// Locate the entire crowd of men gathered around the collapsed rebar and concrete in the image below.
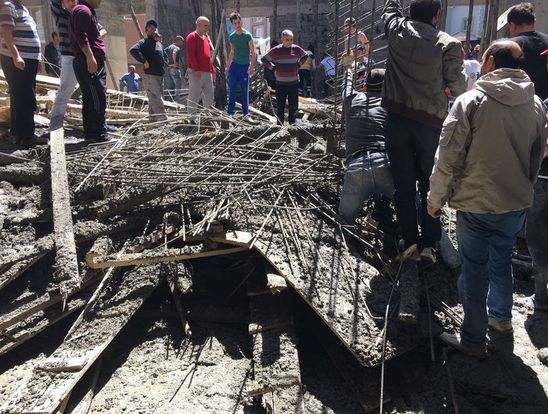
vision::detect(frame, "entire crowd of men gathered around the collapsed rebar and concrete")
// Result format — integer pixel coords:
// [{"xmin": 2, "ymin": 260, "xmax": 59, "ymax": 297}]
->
[{"xmin": 0, "ymin": 0, "xmax": 548, "ymax": 357}]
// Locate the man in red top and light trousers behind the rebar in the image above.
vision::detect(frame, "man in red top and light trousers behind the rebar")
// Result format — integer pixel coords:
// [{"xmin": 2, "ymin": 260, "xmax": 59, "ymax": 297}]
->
[{"xmin": 186, "ymin": 16, "xmax": 215, "ymax": 114}]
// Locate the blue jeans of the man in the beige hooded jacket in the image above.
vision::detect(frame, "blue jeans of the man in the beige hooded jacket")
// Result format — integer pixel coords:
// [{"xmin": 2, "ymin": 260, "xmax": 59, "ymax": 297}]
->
[{"xmin": 457, "ymin": 210, "xmax": 525, "ymax": 344}]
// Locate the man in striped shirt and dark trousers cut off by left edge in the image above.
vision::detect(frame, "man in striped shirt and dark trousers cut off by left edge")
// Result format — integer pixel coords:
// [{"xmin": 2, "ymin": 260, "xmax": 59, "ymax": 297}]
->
[{"xmin": 0, "ymin": 0, "xmax": 40, "ymax": 148}]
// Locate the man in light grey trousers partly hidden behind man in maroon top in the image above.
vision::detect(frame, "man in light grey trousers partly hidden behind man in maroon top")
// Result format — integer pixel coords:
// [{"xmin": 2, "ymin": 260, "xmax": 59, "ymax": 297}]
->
[{"xmin": 49, "ymin": 0, "xmax": 78, "ymax": 131}]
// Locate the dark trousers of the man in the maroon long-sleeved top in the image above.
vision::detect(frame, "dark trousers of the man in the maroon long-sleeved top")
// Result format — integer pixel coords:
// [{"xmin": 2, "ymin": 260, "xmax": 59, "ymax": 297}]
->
[{"xmin": 73, "ymin": 55, "xmax": 107, "ymax": 139}]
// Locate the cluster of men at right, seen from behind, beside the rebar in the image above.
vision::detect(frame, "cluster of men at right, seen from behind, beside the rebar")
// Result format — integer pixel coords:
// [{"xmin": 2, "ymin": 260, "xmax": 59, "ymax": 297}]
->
[{"xmin": 339, "ymin": 0, "xmax": 548, "ymax": 363}]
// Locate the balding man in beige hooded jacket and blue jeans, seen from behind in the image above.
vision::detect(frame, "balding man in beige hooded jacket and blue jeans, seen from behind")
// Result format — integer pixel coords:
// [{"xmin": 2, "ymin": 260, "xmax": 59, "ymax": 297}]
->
[{"xmin": 428, "ymin": 40, "xmax": 548, "ymax": 357}]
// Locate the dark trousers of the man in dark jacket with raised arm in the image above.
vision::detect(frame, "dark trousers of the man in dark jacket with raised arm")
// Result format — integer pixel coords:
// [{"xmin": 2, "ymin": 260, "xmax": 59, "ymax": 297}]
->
[{"xmin": 386, "ymin": 113, "xmax": 441, "ymax": 248}]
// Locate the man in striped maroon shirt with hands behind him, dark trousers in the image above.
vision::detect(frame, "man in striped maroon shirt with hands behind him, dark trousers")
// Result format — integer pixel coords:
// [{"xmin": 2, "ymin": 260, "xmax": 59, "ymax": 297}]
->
[{"xmin": 261, "ymin": 30, "xmax": 307, "ymax": 125}]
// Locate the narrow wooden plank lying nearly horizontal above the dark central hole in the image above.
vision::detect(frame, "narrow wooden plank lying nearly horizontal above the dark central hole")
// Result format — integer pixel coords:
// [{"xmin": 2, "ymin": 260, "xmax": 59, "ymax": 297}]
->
[{"xmin": 86, "ymin": 247, "xmax": 248, "ymax": 269}]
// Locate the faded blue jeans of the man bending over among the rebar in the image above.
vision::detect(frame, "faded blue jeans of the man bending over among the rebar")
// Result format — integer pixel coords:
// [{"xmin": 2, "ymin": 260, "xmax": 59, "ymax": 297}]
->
[{"xmin": 339, "ymin": 152, "xmax": 394, "ymax": 224}]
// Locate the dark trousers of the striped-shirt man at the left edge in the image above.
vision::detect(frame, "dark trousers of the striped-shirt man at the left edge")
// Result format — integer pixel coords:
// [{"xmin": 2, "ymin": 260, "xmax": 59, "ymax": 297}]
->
[{"xmin": 0, "ymin": 56, "xmax": 38, "ymax": 143}]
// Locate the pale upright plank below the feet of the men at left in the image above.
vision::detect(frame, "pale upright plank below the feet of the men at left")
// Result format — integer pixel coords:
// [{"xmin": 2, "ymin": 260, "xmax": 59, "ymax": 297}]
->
[{"xmin": 50, "ymin": 128, "xmax": 81, "ymax": 298}]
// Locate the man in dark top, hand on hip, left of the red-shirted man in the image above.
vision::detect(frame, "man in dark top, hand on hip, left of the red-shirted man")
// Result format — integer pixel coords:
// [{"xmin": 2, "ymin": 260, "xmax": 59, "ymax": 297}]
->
[{"xmin": 129, "ymin": 20, "xmax": 167, "ymax": 121}]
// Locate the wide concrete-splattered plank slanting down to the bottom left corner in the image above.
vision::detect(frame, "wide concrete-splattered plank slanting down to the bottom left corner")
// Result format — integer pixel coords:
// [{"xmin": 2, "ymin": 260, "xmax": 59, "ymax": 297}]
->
[{"xmin": 0, "ymin": 265, "xmax": 165, "ymax": 414}]
